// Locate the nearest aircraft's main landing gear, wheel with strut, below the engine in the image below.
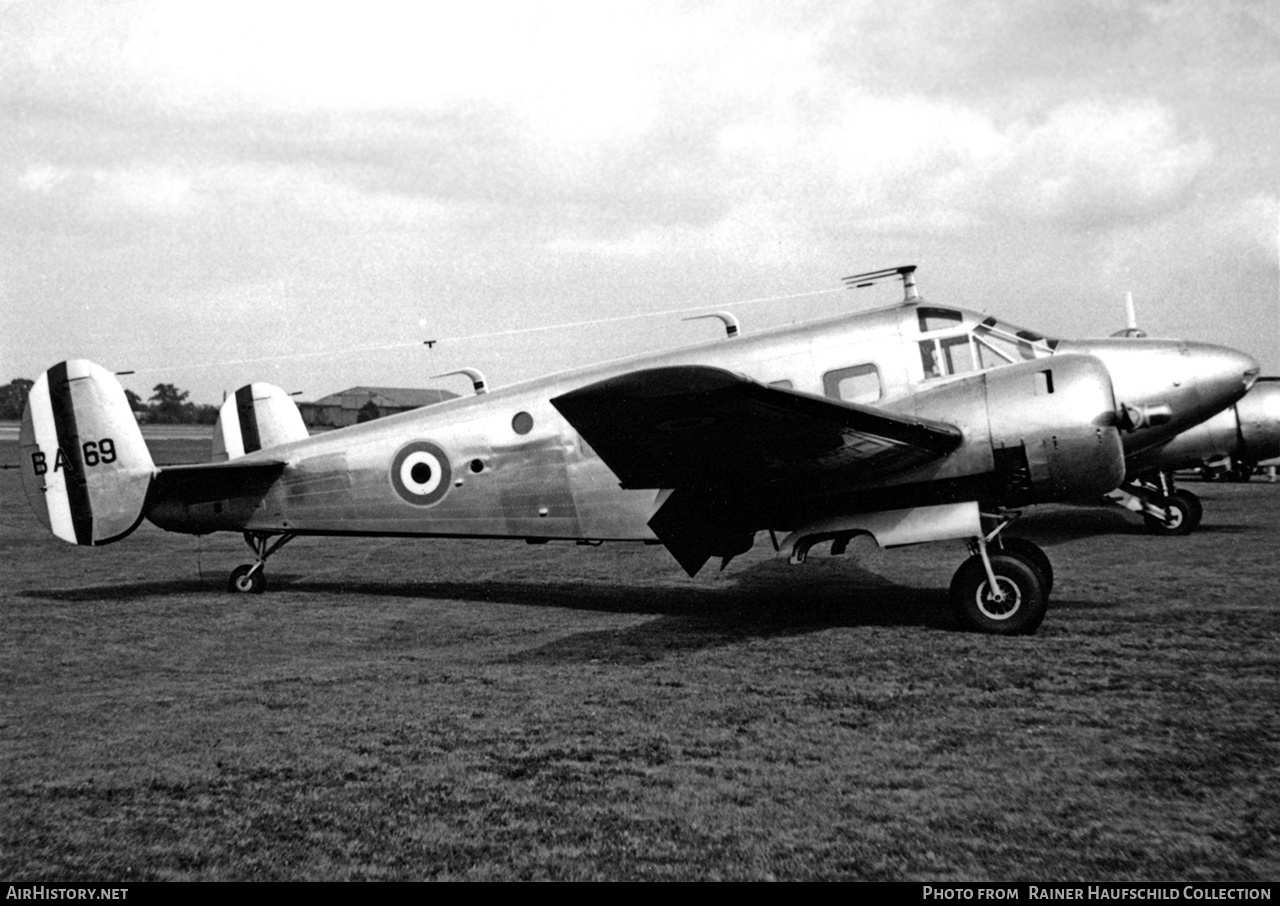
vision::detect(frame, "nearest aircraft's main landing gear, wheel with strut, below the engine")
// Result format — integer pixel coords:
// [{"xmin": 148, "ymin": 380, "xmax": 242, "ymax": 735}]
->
[{"xmin": 950, "ymin": 522, "xmax": 1053, "ymax": 636}]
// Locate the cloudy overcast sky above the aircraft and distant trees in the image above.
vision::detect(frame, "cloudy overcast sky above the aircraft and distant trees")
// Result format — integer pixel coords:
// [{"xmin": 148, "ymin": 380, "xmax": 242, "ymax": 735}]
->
[{"xmin": 0, "ymin": 0, "xmax": 1280, "ymax": 402}]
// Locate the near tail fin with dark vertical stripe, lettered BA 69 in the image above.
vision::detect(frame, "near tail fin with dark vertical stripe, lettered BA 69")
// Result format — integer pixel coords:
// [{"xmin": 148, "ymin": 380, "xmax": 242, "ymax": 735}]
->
[{"xmin": 19, "ymin": 358, "xmax": 155, "ymax": 545}]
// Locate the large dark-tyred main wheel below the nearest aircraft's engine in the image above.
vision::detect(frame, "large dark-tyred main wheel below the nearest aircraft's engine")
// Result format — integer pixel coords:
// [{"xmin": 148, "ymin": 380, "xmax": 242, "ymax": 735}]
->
[{"xmin": 951, "ymin": 552, "xmax": 1048, "ymax": 636}]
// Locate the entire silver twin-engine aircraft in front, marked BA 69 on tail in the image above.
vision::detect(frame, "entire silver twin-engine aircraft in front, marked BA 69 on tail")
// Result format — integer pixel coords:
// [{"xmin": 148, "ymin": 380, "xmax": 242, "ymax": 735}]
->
[{"xmin": 22, "ymin": 266, "xmax": 1258, "ymax": 635}]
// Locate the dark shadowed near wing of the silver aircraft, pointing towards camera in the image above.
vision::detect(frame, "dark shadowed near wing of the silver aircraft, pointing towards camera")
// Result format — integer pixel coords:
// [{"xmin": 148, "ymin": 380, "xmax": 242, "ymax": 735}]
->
[{"xmin": 550, "ymin": 366, "xmax": 961, "ymax": 493}]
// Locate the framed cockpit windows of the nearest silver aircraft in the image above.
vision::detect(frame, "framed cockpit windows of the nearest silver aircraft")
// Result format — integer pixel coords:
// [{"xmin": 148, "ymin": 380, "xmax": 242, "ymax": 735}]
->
[{"xmin": 919, "ymin": 307, "xmax": 1057, "ymax": 380}]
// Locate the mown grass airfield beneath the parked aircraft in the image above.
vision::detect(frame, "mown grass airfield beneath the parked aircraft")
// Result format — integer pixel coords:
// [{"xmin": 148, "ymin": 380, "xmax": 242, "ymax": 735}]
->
[{"xmin": 0, "ymin": 437, "xmax": 1280, "ymax": 880}]
